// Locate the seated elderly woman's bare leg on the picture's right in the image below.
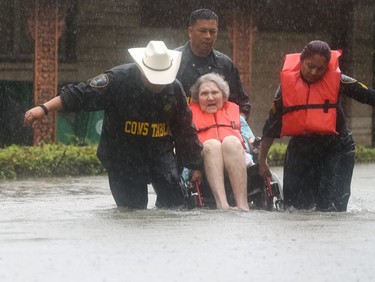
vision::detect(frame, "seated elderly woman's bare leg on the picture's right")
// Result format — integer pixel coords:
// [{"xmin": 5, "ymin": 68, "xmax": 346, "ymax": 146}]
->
[{"xmin": 222, "ymin": 136, "xmax": 249, "ymax": 211}]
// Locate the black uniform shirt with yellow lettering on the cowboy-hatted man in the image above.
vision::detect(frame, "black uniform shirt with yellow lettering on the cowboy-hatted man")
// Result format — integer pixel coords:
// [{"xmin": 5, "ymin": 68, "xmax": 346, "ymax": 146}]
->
[{"xmin": 59, "ymin": 64, "xmax": 202, "ymax": 173}]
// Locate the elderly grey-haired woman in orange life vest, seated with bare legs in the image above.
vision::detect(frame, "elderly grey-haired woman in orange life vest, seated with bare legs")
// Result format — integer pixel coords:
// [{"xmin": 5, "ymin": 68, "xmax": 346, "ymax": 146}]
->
[{"xmin": 190, "ymin": 73, "xmax": 249, "ymax": 211}]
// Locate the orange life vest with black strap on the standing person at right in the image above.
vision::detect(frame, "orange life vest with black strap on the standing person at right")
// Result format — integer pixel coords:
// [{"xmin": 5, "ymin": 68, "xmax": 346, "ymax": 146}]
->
[{"xmin": 280, "ymin": 50, "xmax": 341, "ymax": 136}]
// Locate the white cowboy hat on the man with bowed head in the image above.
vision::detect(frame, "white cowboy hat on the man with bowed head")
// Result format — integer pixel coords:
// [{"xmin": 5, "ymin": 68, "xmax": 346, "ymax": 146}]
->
[{"xmin": 128, "ymin": 41, "xmax": 181, "ymax": 85}]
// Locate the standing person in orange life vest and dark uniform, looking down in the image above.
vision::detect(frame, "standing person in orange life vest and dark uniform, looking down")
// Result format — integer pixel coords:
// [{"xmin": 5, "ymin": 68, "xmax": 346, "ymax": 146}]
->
[{"xmin": 259, "ymin": 40, "xmax": 375, "ymax": 211}]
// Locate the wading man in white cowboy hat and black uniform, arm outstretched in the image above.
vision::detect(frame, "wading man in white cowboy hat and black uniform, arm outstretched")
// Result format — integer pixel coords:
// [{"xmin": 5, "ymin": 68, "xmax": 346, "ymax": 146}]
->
[{"xmin": 24, "ymin": 41, "xmax": 203, "ymax": 209}]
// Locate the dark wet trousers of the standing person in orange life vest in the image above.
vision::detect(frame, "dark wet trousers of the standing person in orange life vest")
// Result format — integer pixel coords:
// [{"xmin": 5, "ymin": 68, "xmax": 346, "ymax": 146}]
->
[{"xmin": 283, "ymin": 132, "xmax": 355, "ymax": 211}]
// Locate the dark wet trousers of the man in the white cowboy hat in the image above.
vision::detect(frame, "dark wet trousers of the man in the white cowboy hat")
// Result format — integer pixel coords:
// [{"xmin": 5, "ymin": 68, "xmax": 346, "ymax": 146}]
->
[{"xmin": 107, "ymin": 152, "xmax": 184, "ymax": 209}]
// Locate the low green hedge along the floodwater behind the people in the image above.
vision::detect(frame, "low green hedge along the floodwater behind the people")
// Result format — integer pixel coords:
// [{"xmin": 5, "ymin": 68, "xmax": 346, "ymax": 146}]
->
[{"xmin": 0, "ymin": 143, "xmax": 375, "ymax": 179}]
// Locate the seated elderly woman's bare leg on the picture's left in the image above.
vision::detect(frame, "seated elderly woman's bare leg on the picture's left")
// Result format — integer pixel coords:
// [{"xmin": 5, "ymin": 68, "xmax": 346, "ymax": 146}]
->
[{"xmin": 202, "ymin": 139, "xmax": 230, "ymax": 209}]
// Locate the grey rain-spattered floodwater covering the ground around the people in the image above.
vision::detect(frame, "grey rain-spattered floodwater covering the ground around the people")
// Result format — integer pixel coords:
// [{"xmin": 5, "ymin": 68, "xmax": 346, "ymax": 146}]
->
[{"xmin": 0, "ymin": 164, "xmax": 375, "ymax": 282}]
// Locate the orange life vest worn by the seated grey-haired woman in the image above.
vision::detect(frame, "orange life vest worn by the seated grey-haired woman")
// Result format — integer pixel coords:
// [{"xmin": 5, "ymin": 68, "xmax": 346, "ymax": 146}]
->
[{"xmin": 189, "ymin": 102, "xmax": 243, "ymax": 145}]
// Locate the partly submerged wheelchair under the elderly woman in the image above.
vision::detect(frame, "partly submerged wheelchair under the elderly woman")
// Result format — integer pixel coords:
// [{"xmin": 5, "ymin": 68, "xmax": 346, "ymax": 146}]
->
[{"xmin": 180, "ymin": 138, "xmax": 285, "ymax": 211}]
